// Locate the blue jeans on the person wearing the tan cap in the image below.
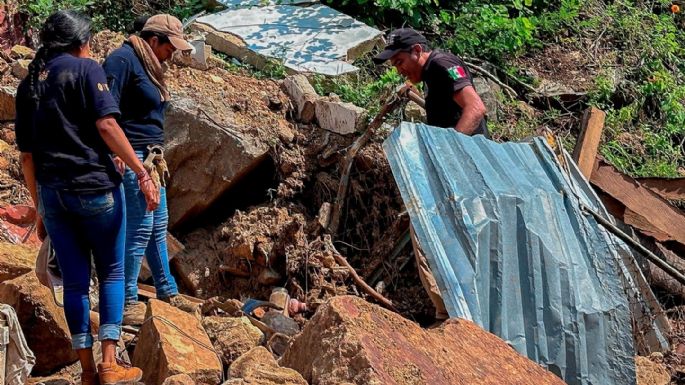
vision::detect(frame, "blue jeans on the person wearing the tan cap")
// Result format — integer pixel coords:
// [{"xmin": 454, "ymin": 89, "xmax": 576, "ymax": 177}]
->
[{"xmin": 124, "ymin": 151, "xmax": 178, "ymax": 304}]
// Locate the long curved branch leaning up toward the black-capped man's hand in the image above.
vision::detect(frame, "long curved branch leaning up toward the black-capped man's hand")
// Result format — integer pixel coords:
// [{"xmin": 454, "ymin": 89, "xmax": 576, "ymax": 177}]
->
[{"xmin": 328, "ymin": 95, "xmax": 402, "ymax": 235}]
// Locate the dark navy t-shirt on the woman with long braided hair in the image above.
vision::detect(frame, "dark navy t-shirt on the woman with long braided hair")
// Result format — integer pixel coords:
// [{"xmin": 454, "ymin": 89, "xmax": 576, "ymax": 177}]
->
[{"xmin": 15, "ymin": 53, "xmax": 121, "ymax": 192}]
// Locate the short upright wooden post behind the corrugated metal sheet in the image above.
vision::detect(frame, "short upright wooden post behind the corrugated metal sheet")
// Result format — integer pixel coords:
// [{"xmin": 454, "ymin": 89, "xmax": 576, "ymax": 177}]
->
[{"xmin": 573, "ymin": 107, "xmax": 606, "ymax": 180}]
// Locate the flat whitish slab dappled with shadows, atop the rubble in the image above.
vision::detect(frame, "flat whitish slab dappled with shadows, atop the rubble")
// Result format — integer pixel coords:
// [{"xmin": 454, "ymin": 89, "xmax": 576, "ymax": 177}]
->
[{"xmin": 197, "ymin": 4, "xmax": 381, "ymax": 75}]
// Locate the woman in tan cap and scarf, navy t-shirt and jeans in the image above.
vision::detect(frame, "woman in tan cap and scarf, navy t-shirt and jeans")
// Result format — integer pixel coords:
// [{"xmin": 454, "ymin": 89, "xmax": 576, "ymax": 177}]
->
[{"xmin": 104, "ymin": 15, "xmax": 197, "ymax": 325}]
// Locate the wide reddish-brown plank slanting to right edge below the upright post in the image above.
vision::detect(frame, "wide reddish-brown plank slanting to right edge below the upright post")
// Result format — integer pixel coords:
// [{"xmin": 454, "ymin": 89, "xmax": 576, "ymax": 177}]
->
[{"xmin": 590, "ymin": 160, "xmax": 685, "ymax": 245}]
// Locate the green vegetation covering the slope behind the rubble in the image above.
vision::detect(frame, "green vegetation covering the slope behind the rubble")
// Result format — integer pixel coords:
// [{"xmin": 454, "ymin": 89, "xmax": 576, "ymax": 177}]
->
[{"xmin": 19, "ymin": 0, "xmax": 685, "ymax": 176}]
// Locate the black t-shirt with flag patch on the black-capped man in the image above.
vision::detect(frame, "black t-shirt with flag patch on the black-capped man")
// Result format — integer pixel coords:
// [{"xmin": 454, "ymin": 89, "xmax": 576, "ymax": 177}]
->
[{"xmin": 421, "ymin": 51, "xmax": 488, "ymax": 137}]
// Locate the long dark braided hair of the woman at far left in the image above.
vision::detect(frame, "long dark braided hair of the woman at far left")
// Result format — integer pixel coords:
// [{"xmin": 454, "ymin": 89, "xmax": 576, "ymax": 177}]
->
[{"xmin": 28, "ymin": 10, "xmax": 92, "ymax": 105}]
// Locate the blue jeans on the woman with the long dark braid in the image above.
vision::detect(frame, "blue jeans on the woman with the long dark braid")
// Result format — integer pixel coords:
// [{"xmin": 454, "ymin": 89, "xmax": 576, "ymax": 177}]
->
[{"xmin": 37, "ymin": 185, "xmax": 126, "ymax": 349}]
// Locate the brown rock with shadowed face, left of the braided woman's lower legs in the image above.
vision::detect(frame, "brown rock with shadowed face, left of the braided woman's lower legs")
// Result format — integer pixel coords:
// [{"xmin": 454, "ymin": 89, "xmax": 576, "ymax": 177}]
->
[{"xmin": 0, "ymin": 272, "xmax": 78, "ymax": 375}]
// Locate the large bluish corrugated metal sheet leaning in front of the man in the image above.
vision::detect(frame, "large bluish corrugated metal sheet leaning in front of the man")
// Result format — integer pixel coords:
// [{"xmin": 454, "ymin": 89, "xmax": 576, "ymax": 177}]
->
[{"xmin": 384, "ymin": 123, "xmax": 651, "ymax": 385}]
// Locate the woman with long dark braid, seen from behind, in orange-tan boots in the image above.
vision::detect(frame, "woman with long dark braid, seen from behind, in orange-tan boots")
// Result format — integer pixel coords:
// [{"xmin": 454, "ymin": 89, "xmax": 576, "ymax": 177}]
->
[{"xmin": 15, "ymin": 11, "xmax": 159, "ymax": 385}]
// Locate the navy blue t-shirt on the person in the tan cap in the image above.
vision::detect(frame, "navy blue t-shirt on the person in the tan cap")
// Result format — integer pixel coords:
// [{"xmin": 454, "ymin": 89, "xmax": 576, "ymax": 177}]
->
[{"xmin": 103, "ymin": 42, "xmax": 168, "ymax": 151}]
